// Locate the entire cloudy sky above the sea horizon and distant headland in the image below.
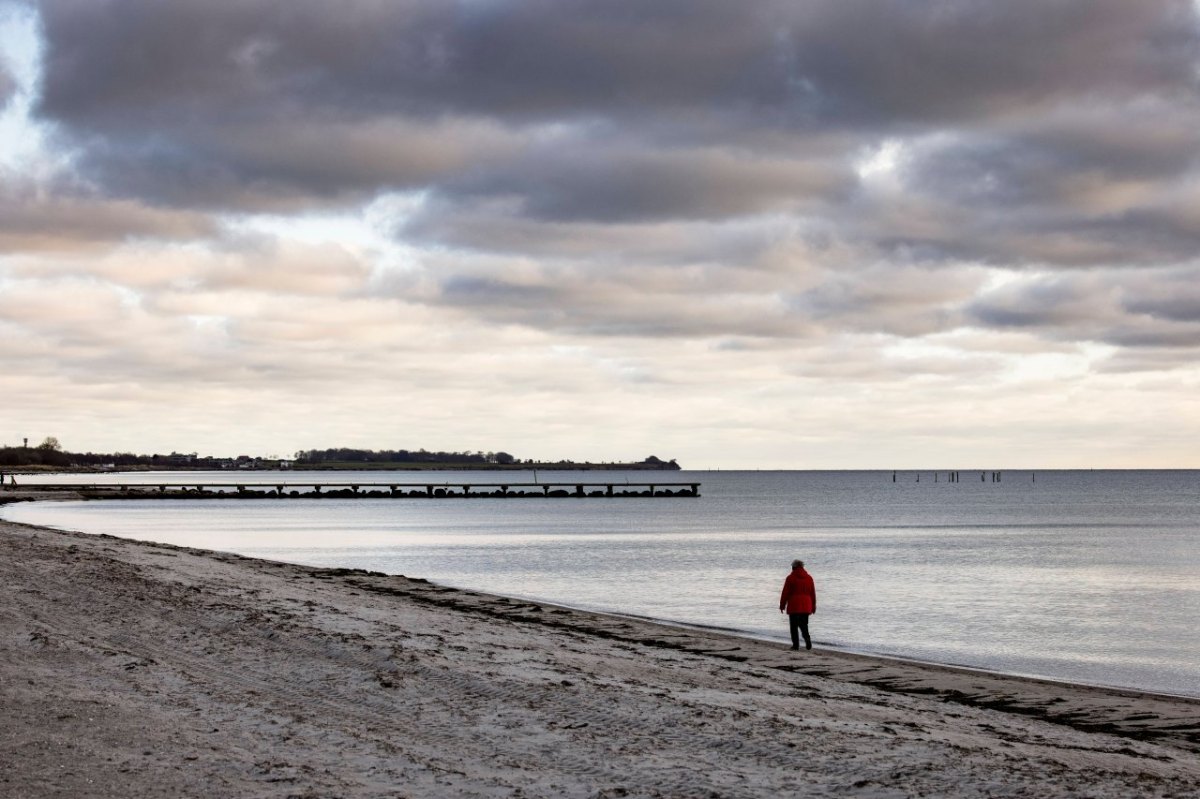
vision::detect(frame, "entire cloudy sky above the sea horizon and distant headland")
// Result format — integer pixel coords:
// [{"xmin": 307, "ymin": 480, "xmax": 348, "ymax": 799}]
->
[{"xmin": 0, "ymin": 0, "xmax": 1200, "ymax": 469}]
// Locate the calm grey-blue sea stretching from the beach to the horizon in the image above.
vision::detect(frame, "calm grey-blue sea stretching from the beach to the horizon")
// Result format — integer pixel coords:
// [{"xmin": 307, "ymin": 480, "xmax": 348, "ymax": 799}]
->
[{"xmin": 0, "ymin": 471, "xmax": 1200, "ymax": 696}]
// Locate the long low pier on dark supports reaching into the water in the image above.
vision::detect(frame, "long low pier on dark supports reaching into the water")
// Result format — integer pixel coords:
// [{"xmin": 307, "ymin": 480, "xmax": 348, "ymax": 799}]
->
[{"xmin": 22, "ymin": 480, "xmax": 700, "ymax": 499}]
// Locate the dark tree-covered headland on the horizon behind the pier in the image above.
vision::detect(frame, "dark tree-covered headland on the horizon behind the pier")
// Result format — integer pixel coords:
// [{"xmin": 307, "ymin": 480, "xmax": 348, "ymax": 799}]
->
[{"xmin": 0, "ymin": 437, "xmax": 682, "ymax": 473}]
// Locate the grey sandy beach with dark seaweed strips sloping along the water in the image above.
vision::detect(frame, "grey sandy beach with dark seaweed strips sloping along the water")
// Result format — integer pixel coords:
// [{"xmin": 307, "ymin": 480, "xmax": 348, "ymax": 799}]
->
[{"xmin": 0, "ymin": 513, "xmax": 1200, "ymax": 798}]
